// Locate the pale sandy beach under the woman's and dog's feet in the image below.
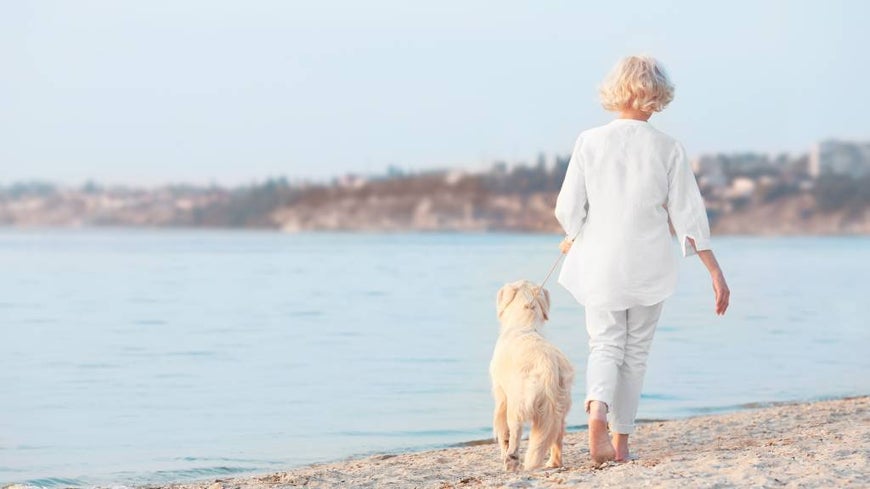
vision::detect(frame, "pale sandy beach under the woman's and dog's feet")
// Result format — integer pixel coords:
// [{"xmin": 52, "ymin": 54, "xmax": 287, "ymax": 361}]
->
[{"xmin": 112, "ymin": 397, "xmax": 870, "ymax": 489}]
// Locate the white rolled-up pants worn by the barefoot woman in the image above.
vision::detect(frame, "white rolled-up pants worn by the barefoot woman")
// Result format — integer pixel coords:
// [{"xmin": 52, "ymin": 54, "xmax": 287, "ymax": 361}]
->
[{"xmin": 586, "ymin": 302, "xmax": 664, "ymax": 434}]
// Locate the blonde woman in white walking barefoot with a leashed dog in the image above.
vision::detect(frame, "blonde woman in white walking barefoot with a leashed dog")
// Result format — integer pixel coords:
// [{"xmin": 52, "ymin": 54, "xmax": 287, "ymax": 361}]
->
[{"xmin": 555, "ymin": 56, "xmax": 730, "ymax": 463}]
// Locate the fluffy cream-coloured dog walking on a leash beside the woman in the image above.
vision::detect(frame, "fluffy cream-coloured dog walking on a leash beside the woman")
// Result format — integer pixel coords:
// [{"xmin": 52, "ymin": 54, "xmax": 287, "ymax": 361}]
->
[{"xmin": 489, "ymin": 280, "xmax": 574, "ymax": 470}]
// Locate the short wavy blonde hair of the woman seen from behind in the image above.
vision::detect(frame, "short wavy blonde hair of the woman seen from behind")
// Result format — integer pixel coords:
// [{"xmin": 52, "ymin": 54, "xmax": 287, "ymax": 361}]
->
[{"xmin": 598, "ymin": 56, "xmax": 674, "ymax": 112}]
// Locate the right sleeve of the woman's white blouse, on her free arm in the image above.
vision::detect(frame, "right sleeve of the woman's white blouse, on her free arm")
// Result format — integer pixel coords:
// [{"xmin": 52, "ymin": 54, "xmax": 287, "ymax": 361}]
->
[{"xmin": 667, "ymin": 142, "xmax": 711, "ymax": 257}]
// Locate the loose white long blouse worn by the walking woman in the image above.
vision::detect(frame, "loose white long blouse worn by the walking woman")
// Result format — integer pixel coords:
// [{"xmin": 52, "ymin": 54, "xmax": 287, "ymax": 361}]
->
[{"xmin": 555, "ymin": 119, "xmax": 710, "ymax": 310}]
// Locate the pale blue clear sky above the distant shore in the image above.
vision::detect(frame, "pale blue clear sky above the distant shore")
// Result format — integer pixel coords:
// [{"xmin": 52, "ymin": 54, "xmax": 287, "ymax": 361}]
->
[{"xmin": 0, "ymin": 0, "xmax": 870, "ymax": 185}]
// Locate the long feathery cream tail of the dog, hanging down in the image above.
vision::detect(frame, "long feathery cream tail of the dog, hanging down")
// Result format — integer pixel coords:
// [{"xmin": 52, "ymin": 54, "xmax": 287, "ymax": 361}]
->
[{"xmin": 523, "ymin": 355, "xmax": 574, "ymax": 470}]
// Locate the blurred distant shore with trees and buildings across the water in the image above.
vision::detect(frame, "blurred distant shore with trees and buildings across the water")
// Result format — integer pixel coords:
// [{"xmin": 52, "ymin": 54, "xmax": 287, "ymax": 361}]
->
[{"xmin": 0, "ymin": 172, "xmax": 870, "ymax": 236}]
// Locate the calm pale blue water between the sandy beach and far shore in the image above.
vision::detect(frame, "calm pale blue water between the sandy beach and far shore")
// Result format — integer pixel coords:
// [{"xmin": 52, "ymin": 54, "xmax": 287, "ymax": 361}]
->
[{"xmin": 0, "ymin": 230, "xmax": 870, "ymax": 487}]
